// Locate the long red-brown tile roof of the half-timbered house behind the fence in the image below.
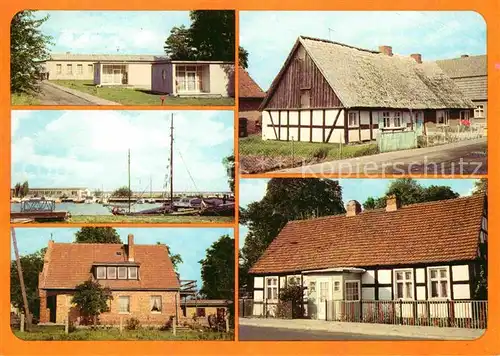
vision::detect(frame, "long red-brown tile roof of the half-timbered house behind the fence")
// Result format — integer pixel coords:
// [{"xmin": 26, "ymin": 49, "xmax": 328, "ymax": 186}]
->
[{"xmin": 250, "ymin": 195, "xmax": 486, "ymax": 274}]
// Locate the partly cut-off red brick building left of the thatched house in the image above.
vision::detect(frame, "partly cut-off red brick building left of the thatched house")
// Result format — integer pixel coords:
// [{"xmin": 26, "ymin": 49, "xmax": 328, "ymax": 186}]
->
[{"xmin": 238, "ymin": 67, "xmax": 266, "ymax": 137}]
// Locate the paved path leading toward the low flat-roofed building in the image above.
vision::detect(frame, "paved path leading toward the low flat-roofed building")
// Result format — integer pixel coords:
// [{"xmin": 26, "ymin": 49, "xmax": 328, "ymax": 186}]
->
[{"xmin": 39, "ymin": 81, "xmax": 121, "ymax": 105}]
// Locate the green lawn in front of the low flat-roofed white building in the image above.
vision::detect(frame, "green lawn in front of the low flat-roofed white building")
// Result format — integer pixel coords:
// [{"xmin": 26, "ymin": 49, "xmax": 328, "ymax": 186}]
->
[{"xmin": 51, "ymin": 80, "xmax": 234, "ymax": 106}]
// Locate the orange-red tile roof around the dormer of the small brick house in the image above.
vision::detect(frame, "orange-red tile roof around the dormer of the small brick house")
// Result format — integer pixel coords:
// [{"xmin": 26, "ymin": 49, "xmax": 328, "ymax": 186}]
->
[{"xmin": 39, "ymin": 243, "xmax": 179, "ymax": 290}]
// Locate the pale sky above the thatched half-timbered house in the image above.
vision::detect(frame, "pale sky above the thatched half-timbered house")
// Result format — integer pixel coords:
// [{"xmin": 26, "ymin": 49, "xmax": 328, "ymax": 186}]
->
[{"xmin": 240, "ymin": 11, "xmax": 486, "ymax": 90}]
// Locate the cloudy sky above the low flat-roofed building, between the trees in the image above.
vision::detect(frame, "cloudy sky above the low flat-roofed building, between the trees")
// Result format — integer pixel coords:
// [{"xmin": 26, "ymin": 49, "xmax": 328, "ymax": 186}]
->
[{"xmin": 37, "ymin": 11, "xmax": 191, "ymax": 54}]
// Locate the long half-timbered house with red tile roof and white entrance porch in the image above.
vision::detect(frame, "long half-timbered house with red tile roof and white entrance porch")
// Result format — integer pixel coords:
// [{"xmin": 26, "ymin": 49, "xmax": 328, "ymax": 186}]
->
[{"xmin": 252, "ymin": 195, "xmax": 487, "ymax": 320}]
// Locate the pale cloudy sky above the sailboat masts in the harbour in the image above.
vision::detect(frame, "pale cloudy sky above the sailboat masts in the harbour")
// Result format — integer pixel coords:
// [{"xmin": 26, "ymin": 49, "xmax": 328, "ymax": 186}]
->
[{"xmin": 11, "ymin": 110, "xmax": 234, "ymax": 192}]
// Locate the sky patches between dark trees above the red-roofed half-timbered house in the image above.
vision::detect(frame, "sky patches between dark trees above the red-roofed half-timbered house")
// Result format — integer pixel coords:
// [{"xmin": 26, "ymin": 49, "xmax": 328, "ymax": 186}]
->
[{"xmin": 239, "ymin": 179, "xmax": 476, "ymax": 248}]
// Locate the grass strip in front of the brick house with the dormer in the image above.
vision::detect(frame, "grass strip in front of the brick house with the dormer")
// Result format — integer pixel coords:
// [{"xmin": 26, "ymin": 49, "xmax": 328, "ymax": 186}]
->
[{"xmin": 14, "ymin": 326, "xmax": 234, "ymax": 341}]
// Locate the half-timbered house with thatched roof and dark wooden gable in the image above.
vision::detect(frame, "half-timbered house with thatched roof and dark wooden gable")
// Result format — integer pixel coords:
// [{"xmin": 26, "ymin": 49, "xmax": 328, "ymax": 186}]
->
[{"xmin": 260, "ymin": 36, "xmax": 475, "ymax": 143}]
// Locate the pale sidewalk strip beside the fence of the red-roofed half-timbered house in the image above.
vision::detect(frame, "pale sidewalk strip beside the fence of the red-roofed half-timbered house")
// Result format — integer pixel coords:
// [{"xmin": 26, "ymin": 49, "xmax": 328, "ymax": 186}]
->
[{"xmin": 239, "ymin": 318, "xmax": 485, "ymax": 340}]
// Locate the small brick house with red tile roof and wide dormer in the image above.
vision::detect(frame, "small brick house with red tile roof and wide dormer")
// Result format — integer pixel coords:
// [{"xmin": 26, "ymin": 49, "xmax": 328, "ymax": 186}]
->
[{"xmin": 38, "ymin": 235, "xmax": 180, "ymax": 325}]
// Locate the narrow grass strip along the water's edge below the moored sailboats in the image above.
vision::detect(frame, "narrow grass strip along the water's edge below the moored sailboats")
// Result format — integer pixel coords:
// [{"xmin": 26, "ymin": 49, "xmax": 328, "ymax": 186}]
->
[{"xmin": 68, "ymin": 215, "xmax": 234, "ymax": 224}]
